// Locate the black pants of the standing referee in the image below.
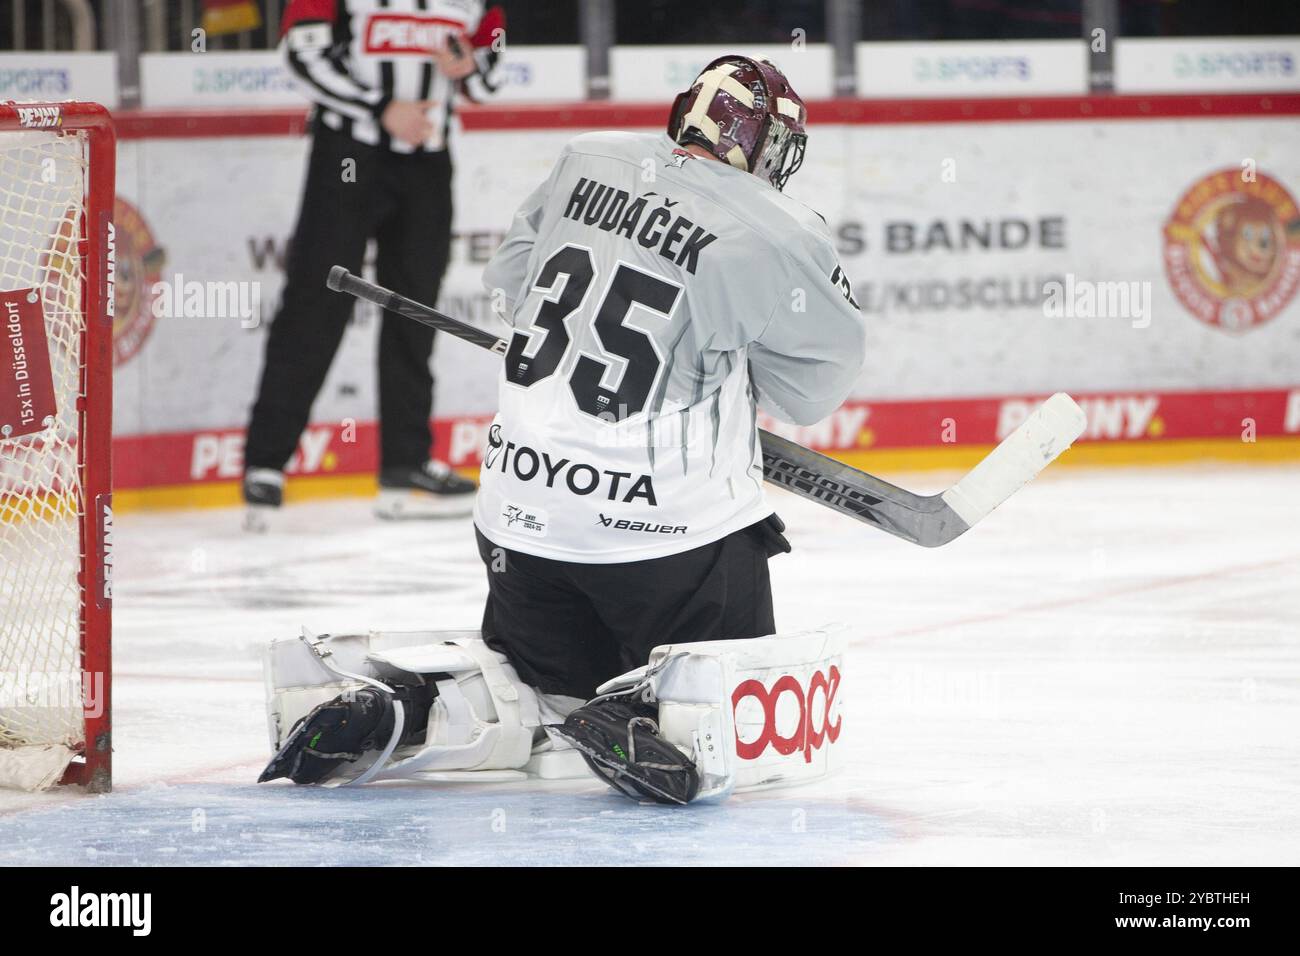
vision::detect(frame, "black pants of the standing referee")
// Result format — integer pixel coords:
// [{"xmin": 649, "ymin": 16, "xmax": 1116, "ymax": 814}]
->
[{"xmin": 244, "ymin": 122, "xmax": 451, "ymax": 470}]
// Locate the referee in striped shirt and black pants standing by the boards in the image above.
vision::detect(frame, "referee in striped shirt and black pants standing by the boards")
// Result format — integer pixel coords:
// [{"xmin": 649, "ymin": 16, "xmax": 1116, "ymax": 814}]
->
[{"xmin": 243, "ymin": 0, "xmax": 504, "ymax": 531}]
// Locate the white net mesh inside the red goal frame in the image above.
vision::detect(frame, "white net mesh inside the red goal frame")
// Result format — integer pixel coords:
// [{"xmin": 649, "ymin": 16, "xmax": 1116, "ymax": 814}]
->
[{"xmin": 0, "ymin": 130, "xmax": 87, "ymax": 748}]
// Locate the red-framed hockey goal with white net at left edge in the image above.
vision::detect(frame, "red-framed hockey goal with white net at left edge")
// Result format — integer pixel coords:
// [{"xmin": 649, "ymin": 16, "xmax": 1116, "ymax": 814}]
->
[{"xmin": 0, "ymin": 103, "xmax": 114, "ymax": 791}]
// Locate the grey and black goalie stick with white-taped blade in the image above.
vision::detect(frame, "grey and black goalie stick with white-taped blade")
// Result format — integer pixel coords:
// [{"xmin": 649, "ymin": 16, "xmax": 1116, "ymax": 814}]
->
[{"xmin": 326, "ymin": 265, "xmax": 1086, "ymax": 548}]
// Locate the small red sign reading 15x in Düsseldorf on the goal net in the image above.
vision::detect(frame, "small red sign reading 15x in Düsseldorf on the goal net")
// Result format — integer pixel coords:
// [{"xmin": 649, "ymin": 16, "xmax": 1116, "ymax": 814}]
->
[{"xmin": 0, "ymin": 289, "xmax": 59, "ymax": 441}]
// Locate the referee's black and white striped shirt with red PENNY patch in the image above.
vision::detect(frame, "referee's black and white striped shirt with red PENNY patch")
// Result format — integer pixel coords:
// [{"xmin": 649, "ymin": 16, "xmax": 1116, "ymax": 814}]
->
[{"xmin": 280, "ymin": 0, "xmax": 506, "ymax": 152}]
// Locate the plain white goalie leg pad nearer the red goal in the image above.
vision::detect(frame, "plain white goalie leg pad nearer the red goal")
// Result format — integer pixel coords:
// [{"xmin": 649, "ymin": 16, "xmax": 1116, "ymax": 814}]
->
[{"xmin": 265, "ymin": 631, "xmax": 553, "ymax": 783}]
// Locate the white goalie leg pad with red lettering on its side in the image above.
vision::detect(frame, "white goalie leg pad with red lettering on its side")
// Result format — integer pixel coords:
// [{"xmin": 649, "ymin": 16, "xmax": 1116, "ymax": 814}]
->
[{"xmin": 599, "ymin": 631, "xmax": 845, "ymax": 799}]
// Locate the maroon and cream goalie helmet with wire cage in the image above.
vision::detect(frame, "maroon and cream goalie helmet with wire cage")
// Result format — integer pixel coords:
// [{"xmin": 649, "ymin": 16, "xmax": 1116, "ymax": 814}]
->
[{"xmin": 668, "ymin": 56, "xmax": 807, "ymax": 189}]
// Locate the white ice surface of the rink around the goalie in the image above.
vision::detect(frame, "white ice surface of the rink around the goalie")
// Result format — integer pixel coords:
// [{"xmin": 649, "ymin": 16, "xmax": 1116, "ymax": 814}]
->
[{"xmin": 0, "ymin": 466, "xmax": 1300, "ymax": 865}]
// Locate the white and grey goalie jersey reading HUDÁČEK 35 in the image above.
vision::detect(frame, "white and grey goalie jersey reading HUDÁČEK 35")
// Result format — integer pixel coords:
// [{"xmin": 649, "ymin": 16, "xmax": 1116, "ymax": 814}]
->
[{"xmin": 475, "ymin": 133, "xmax": 865, "ymax": 563}]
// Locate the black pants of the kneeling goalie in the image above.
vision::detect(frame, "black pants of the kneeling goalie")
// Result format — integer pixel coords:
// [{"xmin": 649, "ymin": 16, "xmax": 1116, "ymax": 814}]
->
[{"xmin": 475, "ymin": 515, "xmax": 790, "ymax": 700}]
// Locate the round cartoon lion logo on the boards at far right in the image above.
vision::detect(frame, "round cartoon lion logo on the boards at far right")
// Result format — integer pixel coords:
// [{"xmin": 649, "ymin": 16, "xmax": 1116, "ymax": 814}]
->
[{"xmin": 1165, "ymin": 168, "xmax": 1300, "ymax": 332}]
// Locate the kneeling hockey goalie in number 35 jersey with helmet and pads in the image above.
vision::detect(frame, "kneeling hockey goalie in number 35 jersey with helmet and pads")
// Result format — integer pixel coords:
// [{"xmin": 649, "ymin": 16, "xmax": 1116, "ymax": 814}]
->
[{"xmin": 261, "ymin": 56, "xmax": 865, "ymax": 804}]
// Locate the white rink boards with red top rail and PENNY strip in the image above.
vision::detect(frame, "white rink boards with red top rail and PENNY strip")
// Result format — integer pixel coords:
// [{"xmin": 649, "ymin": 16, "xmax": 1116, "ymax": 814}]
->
[{"xmin": 91, "ymin": 95, "xmax": 1300, "ymax": 505}]
